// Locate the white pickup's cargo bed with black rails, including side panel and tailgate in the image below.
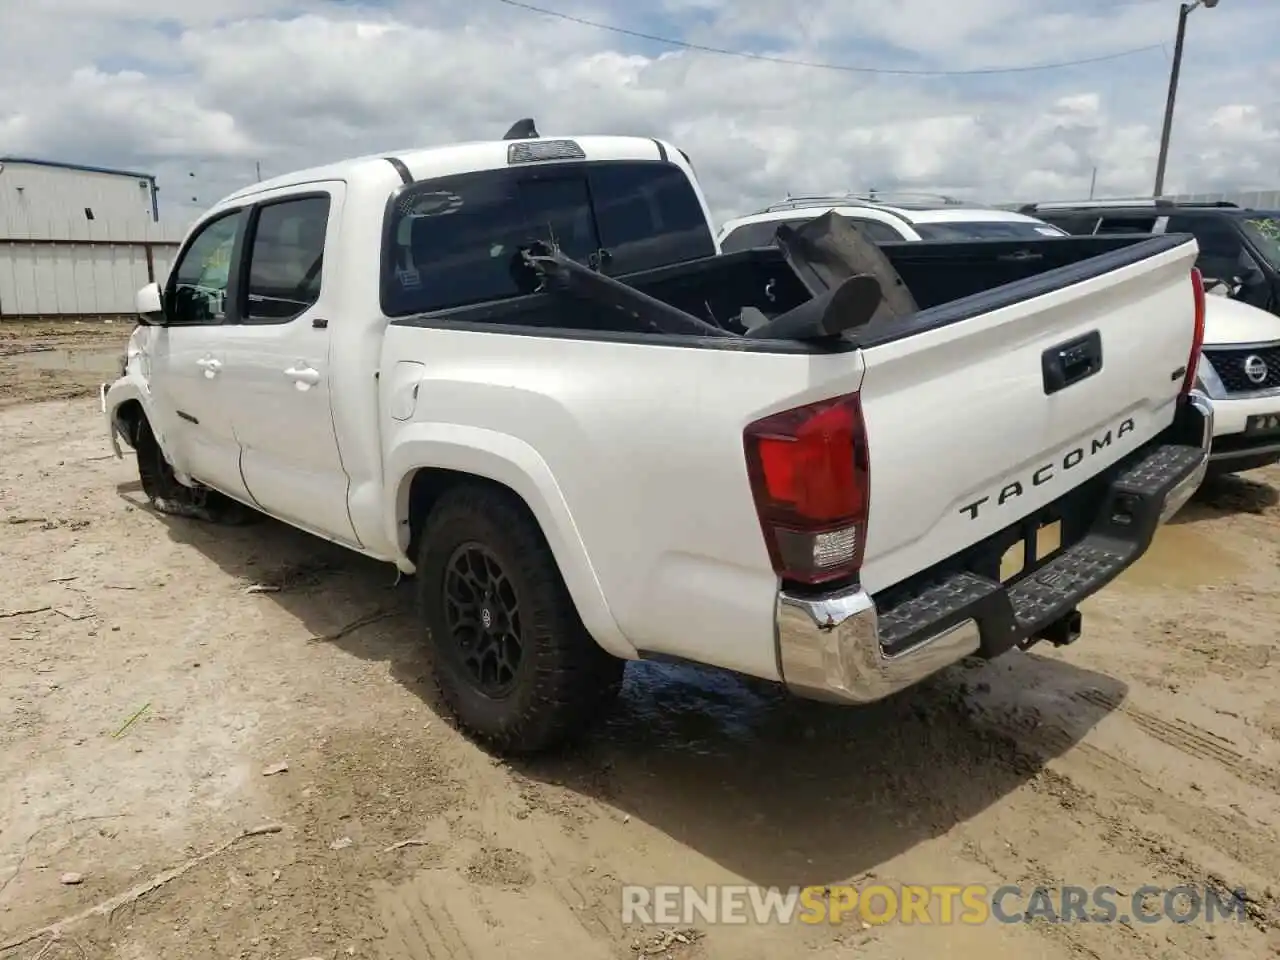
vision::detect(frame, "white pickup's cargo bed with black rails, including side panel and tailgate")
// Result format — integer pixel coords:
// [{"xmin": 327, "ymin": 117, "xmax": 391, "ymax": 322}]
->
[{"xmin": 379, "ymin": 222, "xmax": 1198, "ymax": 677}]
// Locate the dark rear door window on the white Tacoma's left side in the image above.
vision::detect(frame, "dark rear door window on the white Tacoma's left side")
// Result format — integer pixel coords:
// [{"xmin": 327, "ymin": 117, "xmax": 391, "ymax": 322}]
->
[{"xmin": 244, "ymin": 196, "xmax": 329, "ymax": 324}]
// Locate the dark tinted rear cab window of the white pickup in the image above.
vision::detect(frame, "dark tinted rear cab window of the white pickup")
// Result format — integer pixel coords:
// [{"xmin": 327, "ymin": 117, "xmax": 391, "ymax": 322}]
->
[{"xmin": 381, "ymin": 160, "xmax": 716, "ymax": 316}]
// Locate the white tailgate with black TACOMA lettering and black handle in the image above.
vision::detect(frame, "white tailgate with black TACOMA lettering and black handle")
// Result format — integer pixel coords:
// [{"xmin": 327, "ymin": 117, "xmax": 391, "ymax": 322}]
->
[{"xmin": 860, "ymin": 238, "xmax": 1197, "ymax": 594}]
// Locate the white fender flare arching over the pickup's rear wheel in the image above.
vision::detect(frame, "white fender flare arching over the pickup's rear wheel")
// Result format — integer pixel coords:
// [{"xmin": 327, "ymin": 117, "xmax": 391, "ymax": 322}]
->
[{"xmin": 385, "ymin": 424, "xmax": 639, "ymax": 659}]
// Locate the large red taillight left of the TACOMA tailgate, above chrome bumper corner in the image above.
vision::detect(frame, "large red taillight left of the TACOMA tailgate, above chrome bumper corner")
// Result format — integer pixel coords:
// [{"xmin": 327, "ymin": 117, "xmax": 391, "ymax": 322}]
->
[{"xmin": 742, "ymin": 393, "xmax": 870, "ymax": 584}]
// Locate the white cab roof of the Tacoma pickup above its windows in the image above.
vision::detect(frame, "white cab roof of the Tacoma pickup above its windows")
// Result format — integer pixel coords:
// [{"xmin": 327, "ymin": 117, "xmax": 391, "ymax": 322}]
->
[{"xmin": 219, "ymin": 136, "xmax": 680, "ymax": 205}]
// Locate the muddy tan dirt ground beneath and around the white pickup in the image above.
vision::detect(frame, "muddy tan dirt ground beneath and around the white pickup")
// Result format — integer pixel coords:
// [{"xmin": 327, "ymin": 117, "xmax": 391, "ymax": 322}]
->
[{"xmin": 0, "ymin": 328, "xmax": 1280, "ymax": 960}]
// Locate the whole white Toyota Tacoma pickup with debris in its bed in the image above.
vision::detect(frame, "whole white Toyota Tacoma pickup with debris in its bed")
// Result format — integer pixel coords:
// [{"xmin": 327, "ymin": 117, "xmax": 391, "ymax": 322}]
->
[{"xmin": 102, "ymin": 128, "xmax": 1212, "ymax": 751}]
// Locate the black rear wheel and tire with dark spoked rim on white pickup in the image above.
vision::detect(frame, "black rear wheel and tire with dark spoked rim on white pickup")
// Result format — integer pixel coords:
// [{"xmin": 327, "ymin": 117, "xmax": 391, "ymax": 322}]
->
[{"xmin": 416, "ymin": 484, "xmax": 625, "ymax": 754}]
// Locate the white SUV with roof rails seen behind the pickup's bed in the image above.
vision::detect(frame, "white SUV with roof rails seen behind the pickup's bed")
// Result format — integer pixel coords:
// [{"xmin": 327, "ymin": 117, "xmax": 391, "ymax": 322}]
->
[{"xmin": 718, "ymin": 193, "xmax": 1070, "ymax": 253}]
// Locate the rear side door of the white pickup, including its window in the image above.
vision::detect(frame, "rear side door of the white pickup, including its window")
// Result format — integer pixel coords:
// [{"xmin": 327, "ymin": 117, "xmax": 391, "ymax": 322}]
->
[{"xmin": 218, "ymin": 182, "xmax": 361, "ymax": 547}]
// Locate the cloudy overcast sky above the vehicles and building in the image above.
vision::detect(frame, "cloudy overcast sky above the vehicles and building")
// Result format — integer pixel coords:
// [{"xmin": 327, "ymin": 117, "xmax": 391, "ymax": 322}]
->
[{"xmin": 0, "ymin": 0, "xmax": 1280, "ymax": 227}]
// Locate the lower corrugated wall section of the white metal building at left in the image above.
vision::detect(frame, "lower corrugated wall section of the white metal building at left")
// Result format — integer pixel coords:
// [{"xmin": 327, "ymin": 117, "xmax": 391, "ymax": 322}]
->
[{"xmin": 0, "ymin": 209, "xmax": 182, "ymax": 321}]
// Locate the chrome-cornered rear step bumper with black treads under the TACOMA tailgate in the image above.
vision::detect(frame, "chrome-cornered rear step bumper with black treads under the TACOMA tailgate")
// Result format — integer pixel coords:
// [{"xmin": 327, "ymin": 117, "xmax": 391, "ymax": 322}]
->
[{"xmin": 776, "ymin": 393, "xmax": 1213, "ymax": 703}]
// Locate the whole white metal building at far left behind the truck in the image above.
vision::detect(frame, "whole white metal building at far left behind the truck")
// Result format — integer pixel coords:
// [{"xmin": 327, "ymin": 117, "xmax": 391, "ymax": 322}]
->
[{"xmin": 0, "ymin": 156, "xmax": 180, "ymax": 321}]
